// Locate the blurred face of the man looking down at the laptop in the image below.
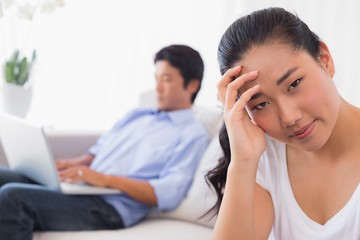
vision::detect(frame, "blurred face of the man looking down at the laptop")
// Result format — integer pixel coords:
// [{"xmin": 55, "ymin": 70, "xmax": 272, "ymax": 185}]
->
[{"xmin": 155, "ymin": 60, "xmax": 193, "ymax": 111}]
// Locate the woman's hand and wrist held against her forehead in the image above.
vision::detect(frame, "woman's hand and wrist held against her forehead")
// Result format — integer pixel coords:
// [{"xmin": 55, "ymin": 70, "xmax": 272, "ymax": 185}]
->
[{"xmin": 217, "ymin": 66, "xmax": 266, "ymax": 161}]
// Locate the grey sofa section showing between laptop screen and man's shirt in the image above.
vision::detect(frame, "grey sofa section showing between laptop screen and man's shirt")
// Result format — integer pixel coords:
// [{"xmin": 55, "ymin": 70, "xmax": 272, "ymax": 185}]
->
[{"xmin": 45, "ymin": 130, "xmax": 101, "ymax": 159}]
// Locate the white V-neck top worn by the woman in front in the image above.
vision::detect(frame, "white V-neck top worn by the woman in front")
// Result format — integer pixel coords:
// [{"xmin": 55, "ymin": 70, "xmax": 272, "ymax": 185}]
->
[{"xmin": 256, "ymin": 137, "xmax": 360, "ymax": 240}]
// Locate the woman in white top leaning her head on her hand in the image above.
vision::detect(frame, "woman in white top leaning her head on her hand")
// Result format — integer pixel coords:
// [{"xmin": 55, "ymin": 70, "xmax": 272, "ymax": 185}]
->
[{"xmin": 207, "ymin": 8, "xmax": 360, "ymax": 240}]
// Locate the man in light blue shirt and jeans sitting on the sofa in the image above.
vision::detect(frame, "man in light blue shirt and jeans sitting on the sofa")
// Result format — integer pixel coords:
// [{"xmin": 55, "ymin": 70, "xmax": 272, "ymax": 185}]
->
[{"xmin": 0, "ymin": 45, "xmax": 209, "ymax": 240}]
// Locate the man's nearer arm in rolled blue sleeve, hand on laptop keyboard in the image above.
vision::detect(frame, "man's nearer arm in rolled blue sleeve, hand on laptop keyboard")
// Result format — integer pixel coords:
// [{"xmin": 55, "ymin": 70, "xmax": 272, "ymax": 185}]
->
[{"xmin": 60, "ymin": 130, "xmax": 209, "ymax": 209}]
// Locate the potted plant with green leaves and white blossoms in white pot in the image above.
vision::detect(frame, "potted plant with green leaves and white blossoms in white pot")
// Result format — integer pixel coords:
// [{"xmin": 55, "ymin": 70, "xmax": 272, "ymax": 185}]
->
[{"xmin": 0, "ymin": 0, "xmax": 65, "ymax": 117}]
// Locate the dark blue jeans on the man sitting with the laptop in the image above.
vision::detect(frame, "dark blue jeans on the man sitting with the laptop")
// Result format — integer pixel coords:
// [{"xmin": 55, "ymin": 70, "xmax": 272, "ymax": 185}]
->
[{"xmin": 0, "ymin": 168, "xmax": 124, "ymax": 240}]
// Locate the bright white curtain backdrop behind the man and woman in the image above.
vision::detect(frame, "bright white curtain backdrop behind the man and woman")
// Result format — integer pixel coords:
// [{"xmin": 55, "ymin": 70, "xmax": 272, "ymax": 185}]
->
[{"xmin": 0, "ymin": 0, "xmax": 360, "ymax": 130}]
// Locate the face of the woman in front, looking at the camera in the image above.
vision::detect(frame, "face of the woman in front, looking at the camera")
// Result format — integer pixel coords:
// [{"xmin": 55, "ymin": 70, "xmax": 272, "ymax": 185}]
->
[{"xmin": 238, "ymin": 43, "xmax": 340, "ymax": 151}]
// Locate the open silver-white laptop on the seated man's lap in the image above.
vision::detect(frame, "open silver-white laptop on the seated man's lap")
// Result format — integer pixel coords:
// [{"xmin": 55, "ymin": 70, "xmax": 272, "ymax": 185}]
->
[{"xmin": 0, "ymin": 113, "xmax": 121, "ymax": 195}]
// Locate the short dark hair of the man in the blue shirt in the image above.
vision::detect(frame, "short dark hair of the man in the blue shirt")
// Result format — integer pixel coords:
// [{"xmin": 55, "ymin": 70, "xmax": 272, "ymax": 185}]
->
[{"xmin": 154, "ymin": 45, "xmax": 204, "ymax": 103}]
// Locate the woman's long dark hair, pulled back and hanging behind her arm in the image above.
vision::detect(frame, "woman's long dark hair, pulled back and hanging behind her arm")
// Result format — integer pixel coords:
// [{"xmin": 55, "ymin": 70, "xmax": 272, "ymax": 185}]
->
[{"xmin": 206, "ymin": 8, "xmax": 320, "ymax": 215}]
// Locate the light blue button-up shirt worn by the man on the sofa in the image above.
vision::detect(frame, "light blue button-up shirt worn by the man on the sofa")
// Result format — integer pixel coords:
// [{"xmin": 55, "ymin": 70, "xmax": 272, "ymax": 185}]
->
[{"xmin": 89, "ymin": 109, "xmax": 209, "ymax": 227}]
